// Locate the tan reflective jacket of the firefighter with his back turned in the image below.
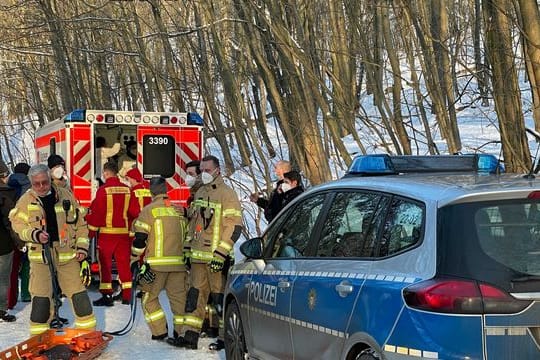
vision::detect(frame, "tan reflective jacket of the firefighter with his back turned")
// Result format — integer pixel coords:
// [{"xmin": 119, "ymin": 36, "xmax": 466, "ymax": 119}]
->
[{"xmin": 131, "ymin": 194, "xmax": 187, "ymax": 272}]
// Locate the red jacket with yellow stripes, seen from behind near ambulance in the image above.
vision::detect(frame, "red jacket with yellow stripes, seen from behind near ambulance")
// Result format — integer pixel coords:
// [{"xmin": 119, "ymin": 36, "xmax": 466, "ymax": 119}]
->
[{"xmin": 86, "ymin": 177, "xmax": 131, "ymax": 235}]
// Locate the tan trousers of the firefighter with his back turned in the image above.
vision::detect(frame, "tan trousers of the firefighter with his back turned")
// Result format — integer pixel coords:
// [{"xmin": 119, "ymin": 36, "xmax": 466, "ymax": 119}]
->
[{"xmin": 141, "ymin": 269, "xmax": 188, "ymax": 336}]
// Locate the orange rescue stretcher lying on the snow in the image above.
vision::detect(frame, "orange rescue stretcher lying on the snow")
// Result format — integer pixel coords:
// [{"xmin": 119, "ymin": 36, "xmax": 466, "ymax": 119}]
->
[{"xmin": 0, "ymin": 329, "xmax": 113, "ymax": 360}]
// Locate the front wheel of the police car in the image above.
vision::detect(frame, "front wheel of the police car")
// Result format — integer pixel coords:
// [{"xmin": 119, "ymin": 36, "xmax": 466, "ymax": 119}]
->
[{"xmin": 224, "ymin": 301, "xmax": 247, "ymax": 360}]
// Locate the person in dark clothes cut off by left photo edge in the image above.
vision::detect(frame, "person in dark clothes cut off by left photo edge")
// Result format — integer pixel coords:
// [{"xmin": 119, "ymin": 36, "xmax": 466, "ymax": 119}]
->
[{"xmin": 0, "ymin": 162, "xmax": 17, "ymax": 322}]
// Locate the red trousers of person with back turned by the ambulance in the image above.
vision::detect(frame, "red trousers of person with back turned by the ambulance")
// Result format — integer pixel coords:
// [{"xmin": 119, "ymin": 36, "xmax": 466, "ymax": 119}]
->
[{"xmin": 98, "ymin": 234, "xmax": 131, "ymax": 301}]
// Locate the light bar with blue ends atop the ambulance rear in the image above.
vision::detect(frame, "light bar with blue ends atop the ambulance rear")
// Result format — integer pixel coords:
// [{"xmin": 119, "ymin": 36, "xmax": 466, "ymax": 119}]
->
[{"xmin": 63, "ymin": 109, "xmax": 204, "ymax": 126}]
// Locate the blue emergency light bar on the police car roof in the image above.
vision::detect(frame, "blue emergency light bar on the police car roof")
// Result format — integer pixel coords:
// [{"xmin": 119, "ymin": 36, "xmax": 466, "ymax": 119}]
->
[{"xmin": 345, "ymin": 154, "xmax": 504, "ymax": 177}]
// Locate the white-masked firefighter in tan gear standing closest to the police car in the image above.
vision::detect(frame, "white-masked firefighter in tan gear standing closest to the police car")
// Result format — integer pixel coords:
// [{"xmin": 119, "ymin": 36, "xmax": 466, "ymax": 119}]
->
[{"xmin": 167, "ymin": 155, "xmax": 242, "ymax": 350}]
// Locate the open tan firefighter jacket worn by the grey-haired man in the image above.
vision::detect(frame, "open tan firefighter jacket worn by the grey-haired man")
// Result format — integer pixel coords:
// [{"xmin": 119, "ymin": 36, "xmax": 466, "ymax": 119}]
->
[{"xmin": 9, "ymin": 185, "xmax": 89, "ymax": 263}]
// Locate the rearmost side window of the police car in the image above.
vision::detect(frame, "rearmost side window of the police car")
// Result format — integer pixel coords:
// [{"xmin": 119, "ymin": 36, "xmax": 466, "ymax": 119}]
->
[{"xmin": 378, "ymin": 197, "xmax": 424, "ymax": 257}]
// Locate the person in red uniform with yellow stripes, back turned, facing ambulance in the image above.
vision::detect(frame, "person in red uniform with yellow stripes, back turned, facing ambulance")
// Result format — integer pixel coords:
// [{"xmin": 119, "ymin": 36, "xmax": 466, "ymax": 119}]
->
[{"xmin": 86, "ymin": 161, "xmax": 131, "ymax": 306}]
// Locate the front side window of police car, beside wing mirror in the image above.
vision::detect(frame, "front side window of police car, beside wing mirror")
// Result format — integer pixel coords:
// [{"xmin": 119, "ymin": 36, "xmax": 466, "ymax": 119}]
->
[{"xmin": 266, "ymin": 194, "xmax": 326, "ymax": 258}]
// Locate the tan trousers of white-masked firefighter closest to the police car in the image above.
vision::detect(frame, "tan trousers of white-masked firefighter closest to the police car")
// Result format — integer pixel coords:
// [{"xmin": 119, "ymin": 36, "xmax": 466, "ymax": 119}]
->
[{"xmin": 182, "ymin": 263, "xmax": 225, "ymax": 332}]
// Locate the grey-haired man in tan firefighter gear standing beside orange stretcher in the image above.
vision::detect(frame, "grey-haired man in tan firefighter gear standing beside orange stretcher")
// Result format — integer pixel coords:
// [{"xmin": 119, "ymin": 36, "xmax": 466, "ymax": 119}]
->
[{"xmin": 9, "ymin": 164, "xmax": 96, "ymax": 334}]
